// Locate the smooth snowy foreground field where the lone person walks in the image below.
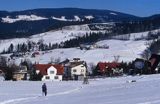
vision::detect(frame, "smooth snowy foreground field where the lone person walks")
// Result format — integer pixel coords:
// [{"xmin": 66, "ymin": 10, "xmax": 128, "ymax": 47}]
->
[{"xmin": 0, "ymin": 74, "xmax": 160, "ymax": 104}]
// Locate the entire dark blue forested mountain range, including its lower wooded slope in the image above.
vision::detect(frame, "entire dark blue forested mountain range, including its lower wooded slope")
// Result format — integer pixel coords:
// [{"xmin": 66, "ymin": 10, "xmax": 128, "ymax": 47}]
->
[{"xmin": 0, "ymin": 8, "xmax": 159, "ymax": 39}]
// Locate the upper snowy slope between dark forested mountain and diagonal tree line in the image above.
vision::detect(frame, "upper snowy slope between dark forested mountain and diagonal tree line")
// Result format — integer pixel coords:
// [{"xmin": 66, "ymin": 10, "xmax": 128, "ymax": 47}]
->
[{"xmin": 0, "ymin": 25, "xmax": 91, "ymax": 52}]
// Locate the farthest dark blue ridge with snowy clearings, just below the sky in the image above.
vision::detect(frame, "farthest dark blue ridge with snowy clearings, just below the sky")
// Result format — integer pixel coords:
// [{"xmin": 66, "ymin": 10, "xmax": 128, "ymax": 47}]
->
[{"xmin": 0, "ymin": 8, "xmax": 139, "ymax": 23}]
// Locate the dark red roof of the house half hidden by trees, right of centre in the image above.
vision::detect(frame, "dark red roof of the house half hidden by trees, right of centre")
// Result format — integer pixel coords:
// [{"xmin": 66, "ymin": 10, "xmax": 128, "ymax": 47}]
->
[{"xmin": 98, "ymin": 62, "xmax": 120, "ymax": 72}]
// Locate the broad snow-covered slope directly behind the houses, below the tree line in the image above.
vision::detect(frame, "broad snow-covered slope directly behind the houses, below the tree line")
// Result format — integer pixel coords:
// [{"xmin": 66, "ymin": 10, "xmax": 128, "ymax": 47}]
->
[{"xmin": 11, "ymin": 40, "xmax": 146, "ymax": 65}]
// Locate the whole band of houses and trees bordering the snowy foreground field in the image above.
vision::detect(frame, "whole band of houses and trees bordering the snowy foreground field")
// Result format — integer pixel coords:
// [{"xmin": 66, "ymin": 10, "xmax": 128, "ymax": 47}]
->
[{"xmin": 0, "ymin": 49, "xmax": 160, "ymax": 81}]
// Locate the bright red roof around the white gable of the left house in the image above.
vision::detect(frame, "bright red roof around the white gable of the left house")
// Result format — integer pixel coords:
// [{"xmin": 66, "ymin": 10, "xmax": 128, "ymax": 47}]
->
[{"xmin": 34, "ymin": 64, "xmax": 64, "ymax": 75}]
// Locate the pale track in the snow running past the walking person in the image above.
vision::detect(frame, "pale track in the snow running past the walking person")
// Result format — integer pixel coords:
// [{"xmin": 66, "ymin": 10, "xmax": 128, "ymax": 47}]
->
[{"xmin": 0, "ymin": 87, "xmax": 82, "ymax": 104}]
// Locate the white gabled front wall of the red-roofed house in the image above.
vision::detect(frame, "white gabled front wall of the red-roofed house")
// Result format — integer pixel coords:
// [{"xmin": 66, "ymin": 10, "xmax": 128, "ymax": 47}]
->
[{"xmin": 42, "ymin": 66, "xmax": 62, "ymax": 81}]
